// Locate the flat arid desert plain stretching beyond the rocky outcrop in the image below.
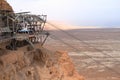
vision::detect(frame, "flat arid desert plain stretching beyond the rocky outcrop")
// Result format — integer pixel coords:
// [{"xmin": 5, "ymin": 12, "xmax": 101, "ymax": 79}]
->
[{"xmin": 44, "ymin": 28, "xmax": 120, "ymax": 80}]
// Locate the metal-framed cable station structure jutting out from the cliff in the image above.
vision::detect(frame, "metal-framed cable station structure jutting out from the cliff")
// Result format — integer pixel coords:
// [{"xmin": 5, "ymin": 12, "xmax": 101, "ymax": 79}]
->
[{"xmin": 0, "ymin": 11, "xmax": 49, "ymax": 50}]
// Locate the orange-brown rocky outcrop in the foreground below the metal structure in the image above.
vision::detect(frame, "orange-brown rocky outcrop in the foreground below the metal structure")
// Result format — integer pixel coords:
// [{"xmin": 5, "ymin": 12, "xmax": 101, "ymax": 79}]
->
[{"xmin": 0, "ymin": 48, "xmax": 84, "ymax": 80}]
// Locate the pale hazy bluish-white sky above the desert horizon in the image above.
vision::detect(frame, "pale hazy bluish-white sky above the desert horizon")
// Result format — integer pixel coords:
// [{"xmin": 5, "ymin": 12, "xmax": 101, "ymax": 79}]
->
[{"xmin": 7, "ymin": 0, "xmax": 120, "ymax": 27}]
